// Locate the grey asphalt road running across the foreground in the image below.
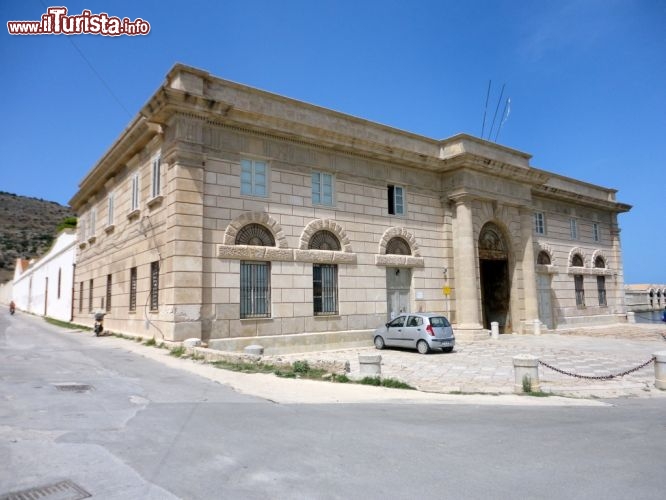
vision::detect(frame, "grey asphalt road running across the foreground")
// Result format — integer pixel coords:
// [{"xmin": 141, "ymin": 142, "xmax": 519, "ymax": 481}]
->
[{"xmin": 0, "ymin": 311, "xmax": 666, "ymax": 500}]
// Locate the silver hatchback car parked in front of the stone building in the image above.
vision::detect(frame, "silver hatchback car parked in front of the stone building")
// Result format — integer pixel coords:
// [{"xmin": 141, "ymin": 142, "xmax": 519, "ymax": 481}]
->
[{"xmin": 374, "ymin": 313, "xmax": 456, "ymax": 354}]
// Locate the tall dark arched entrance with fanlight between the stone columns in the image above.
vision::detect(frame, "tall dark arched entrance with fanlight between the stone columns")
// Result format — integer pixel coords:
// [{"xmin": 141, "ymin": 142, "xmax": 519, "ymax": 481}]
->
[{"xmin": 479, "ymin": 222, "xmax": 511, "ymax": 333}]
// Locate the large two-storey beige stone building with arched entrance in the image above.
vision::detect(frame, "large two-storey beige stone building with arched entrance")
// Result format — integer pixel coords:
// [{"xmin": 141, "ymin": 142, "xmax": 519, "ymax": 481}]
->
[{"xmin": 71, "ymin": 65, "xmax": 630, "ymax": 346}]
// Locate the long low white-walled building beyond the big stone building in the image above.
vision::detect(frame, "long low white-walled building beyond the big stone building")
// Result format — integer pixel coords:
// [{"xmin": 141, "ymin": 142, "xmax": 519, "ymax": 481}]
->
[{"xmin": 11, "ymin": 229, "xmax": 77, "ymax": 321}]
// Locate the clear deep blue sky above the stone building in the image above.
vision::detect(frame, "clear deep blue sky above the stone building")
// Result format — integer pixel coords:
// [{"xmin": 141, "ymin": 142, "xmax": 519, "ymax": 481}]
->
[{"xmin": 0, "ymin": 0, "xmax": 666, "ymax": 283}]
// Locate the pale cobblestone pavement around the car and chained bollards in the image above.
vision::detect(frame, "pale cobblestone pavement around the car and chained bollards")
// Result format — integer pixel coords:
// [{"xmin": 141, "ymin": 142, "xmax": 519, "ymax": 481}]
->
[{"xmin": 268, "ymin": 324, "xmax": 666, "ymax": 398}]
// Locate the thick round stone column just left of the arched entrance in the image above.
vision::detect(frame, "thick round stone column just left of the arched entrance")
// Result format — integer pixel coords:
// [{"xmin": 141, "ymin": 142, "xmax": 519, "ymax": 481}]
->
[{"xmin": 453, "ymin": 198, "xmax": 483, "ymax": 330}]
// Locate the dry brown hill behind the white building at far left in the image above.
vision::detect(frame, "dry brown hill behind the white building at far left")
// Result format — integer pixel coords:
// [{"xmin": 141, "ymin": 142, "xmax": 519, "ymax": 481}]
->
[{"xmin": 0, "ymin": 191, "xmax": 74, "ymax": 283}]
